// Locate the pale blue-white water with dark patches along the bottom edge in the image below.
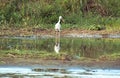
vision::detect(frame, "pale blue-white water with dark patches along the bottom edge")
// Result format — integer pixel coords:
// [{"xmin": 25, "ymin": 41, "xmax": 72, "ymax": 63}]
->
[{"xmin": 0, "ymin": 66, "xmax": 120, "ymax": 78}]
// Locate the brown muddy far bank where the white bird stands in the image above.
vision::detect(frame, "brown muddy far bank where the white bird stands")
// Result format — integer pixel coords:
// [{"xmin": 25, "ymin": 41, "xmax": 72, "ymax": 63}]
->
[{"xmin": 0, "ymin": 28, "xmax": 120, "ymax": 38}]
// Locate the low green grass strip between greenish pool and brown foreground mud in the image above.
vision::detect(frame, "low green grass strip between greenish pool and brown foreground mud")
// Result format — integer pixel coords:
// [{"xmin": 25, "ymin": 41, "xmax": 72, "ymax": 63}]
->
[{"xmin": 0, "ymin": 50, "xmax": 120, "ymax": 63}]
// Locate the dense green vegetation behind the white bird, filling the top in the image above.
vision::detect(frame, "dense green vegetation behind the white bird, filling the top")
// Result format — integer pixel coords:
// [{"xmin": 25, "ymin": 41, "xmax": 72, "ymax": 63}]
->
[{"xmin": 0, "ymin": 0, "xmax": 120, "ymax": 30}]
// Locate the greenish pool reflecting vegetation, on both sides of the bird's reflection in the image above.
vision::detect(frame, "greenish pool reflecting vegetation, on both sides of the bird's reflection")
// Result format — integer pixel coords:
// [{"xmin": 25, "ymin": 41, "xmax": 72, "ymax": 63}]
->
[{"xmin": 0, "ymin": 36, "xmax": 120, "ymax": 58}]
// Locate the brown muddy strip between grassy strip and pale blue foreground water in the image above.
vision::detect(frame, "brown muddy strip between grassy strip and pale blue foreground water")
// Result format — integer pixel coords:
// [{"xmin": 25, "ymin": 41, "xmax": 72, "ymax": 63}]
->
[{"xmin": 0, "ymin": 58, "xmax": 120, "ymax": 69}]
